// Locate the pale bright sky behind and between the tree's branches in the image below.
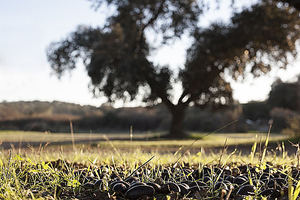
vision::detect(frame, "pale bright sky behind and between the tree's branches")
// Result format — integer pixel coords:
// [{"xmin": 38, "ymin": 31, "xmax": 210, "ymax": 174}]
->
[{"xmin": 0, "ymin": 0, "xmax": 300, "ymax": 107}]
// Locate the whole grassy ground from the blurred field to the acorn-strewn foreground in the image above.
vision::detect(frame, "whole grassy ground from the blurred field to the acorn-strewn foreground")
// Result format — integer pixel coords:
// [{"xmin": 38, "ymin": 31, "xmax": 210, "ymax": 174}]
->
[{"xmin": 0, "ymin": 131, "xmax": 300, "ymax": 200}]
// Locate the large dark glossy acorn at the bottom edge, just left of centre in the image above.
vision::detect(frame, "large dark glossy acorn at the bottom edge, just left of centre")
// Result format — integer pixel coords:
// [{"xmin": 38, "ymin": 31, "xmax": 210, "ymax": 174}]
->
[{"xmin": 125, "ymin": 185, "xmax": 155, "ymax": 199}]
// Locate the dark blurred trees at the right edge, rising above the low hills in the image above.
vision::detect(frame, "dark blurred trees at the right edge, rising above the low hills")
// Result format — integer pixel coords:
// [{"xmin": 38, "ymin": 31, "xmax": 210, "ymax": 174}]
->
[{"xmin": 243, "ymin": 77, "xmax": 300, "ymax": 135}]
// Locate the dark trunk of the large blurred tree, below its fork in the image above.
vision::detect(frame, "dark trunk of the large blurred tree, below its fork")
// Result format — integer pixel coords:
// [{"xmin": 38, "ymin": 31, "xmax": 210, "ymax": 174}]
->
[{"xmin": 167, "ymin": 105, "xmax": 188, "ymax": 138}]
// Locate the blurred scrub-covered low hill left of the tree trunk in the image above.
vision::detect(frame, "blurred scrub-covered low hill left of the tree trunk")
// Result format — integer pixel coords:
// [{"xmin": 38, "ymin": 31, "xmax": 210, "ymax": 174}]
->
[{"xmin": 0, "ymin": 101, "xmax": 169, "ymax": 132}]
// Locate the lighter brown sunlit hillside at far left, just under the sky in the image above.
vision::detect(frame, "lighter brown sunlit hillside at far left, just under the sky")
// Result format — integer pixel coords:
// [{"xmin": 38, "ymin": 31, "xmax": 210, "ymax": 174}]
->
[{"xmin": 0, "ymin": 101, "xmax": 103, "ymax": 121}]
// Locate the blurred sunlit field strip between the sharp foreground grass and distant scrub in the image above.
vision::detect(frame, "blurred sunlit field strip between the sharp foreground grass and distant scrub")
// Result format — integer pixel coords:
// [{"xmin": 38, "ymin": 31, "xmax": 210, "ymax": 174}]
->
[{"xmin": 0, "ymin": 131, "xmax": 295, "ymax": 154}]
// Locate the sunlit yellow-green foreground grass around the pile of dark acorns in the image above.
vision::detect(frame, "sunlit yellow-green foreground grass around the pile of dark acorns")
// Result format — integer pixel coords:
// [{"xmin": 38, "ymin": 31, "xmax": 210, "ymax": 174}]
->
[{"xmin": 0, "ymin": 137, "xmax": 299, "ymax": 199}]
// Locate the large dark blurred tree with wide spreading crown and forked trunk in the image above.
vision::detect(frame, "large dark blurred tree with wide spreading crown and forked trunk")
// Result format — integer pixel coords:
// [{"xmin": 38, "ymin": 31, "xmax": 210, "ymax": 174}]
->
[{"xmin": 47, "ymin": 0, "xmax": 300, "ymax": 137}]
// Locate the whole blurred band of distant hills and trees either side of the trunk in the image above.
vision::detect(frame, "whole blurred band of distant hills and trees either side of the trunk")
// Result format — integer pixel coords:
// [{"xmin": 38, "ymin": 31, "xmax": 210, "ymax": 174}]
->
[{"xmin": 0, "ymin": 78, "xmax": 300, "ymax": 135}]
